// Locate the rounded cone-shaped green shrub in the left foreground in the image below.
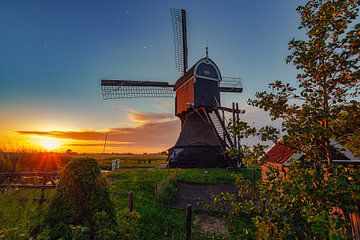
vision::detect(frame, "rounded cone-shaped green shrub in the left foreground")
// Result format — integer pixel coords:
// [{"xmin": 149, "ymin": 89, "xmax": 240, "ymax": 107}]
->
[{"xmin": 45, "ymin": 158, "xmax": 117, "ymax": 239}]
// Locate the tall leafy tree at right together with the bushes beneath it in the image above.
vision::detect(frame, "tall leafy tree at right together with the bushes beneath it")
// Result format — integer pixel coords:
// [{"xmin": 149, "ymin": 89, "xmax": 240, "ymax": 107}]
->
[{"xmin": 218, "ymin": 0, "xmax": 360, "ymax": 239}]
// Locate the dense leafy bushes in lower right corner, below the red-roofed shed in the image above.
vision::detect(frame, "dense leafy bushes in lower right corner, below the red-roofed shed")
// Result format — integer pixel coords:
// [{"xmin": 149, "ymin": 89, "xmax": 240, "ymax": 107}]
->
[{"xmin": 217, "ymin": 163, "xmax": 360, "ymax": 239}]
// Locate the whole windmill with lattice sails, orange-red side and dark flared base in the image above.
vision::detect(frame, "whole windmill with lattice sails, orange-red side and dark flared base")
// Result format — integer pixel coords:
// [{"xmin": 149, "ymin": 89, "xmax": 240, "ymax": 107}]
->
[{"xmin": 101, "ymin": 9, "xmax": 243, "ymax": 168}]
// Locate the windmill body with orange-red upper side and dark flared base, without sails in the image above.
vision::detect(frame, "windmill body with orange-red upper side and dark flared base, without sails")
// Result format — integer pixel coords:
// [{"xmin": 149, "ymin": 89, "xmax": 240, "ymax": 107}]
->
[{"xmin": 168, "ymin": 58, "xmax": 228, "ymax": 167}]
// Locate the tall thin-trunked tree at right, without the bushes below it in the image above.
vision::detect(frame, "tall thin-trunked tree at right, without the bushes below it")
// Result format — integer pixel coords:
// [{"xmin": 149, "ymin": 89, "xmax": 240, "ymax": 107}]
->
[{"xmin": 249, "ymin": 0, "xmax": 360, "ymax": 164}]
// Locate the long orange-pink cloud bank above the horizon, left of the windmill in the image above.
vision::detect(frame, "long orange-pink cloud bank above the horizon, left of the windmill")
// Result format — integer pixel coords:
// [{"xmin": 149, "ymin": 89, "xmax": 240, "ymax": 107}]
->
[{"xmin": 16, "ymin": 112, "xmax": 180, "ymax": 149}]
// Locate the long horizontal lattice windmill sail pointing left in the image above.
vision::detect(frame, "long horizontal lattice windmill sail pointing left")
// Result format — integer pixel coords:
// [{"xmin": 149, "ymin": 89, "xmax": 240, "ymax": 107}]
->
[{"xmin": 101, "ymin": 80, "xmax": 175, "ymax": 100}]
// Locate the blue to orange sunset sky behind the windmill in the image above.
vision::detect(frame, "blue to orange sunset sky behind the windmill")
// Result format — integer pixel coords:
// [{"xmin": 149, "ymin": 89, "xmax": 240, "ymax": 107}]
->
[{"xmin": 0, "ymin": 0, "xmax": 305, "ymax": 153}]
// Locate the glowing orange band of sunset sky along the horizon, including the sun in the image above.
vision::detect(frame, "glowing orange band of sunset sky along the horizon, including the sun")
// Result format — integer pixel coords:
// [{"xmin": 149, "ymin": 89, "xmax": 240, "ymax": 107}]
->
[{"xmin": 0, "ymin": 112, "xmax": 180, "ymax": 153}]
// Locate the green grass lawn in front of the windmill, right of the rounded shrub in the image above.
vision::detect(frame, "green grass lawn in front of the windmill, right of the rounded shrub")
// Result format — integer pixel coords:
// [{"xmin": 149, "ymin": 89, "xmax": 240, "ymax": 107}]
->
[{"xmin": 107, "ymin": 169, "xmax": 260, "ymax": 239}]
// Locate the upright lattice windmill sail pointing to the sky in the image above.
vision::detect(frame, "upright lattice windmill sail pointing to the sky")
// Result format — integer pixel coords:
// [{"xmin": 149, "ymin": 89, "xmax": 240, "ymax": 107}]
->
[{"xmin": 170, "ymin": 8, "xmax": 188, "ymax": 74}]
